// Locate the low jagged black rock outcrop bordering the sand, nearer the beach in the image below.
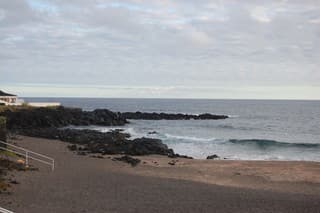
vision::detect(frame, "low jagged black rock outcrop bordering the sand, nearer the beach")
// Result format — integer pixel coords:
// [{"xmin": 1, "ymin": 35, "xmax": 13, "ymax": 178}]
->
[{"xmin": 18, "ymin": 128, "xmax": 175, "ymax": 156}]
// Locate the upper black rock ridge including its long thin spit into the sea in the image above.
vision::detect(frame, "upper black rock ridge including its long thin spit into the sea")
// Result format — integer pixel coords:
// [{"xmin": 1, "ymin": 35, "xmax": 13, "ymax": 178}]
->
[{"xmin": 0, "ymin": 106, "xmax": 228, "ymax": 130}]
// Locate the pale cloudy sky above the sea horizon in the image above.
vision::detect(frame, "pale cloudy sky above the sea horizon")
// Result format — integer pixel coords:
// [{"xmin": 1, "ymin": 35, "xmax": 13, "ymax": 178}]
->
[{"xmin": 0, "ymin": 0, "xmax": 320, "ymax": 99}]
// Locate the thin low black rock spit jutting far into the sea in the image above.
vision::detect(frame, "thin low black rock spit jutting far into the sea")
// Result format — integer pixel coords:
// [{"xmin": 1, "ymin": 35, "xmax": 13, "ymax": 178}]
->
[{"xmin": 121, "ymin": 112, "xmax": 228, "ymax": 120}]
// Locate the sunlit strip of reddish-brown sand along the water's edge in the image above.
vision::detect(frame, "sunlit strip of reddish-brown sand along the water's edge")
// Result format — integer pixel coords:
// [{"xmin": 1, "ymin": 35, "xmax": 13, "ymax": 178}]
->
[{"xmin": 115, "ymin": 155, "xmax": 320, "ymax": 195}]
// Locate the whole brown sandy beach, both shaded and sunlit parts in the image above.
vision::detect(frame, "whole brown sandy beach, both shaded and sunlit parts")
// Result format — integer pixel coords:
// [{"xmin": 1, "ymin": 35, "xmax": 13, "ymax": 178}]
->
[{"xmin": 0, "ymin": 137, "xmax": 320, "ymax": 213}]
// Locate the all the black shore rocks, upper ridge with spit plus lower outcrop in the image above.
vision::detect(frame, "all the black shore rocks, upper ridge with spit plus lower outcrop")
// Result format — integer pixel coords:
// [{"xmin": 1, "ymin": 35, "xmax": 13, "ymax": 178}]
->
[{"xmin": 0, "ymin": 107, "xmax": 228, "ymax": 158}]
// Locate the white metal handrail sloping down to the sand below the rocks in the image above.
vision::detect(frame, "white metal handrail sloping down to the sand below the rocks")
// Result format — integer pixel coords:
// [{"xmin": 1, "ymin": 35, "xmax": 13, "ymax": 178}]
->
[{"xmin": 0, "ymin": 141, "xmax": 55, "ymax": 171}]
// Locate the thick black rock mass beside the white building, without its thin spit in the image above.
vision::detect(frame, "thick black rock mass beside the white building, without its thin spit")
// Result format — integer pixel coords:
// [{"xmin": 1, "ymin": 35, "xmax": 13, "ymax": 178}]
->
[{"xmin": 0, "ymin": 107, "xmax": 127, "ymax": 130}]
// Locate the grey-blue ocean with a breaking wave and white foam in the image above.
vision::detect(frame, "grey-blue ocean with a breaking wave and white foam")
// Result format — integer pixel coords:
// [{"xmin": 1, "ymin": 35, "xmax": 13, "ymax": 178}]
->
[{"xmin": 24, "ymin": 98, "xmax": 320, "ymax": 161}]
